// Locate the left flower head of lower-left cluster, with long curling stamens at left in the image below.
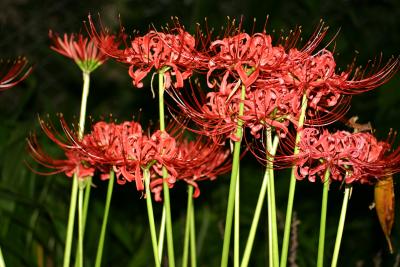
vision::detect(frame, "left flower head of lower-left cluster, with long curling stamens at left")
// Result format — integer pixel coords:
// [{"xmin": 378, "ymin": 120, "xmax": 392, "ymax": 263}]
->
[{"xmin": 28, "ymin": 118, "xmax": 181, "ymax": 199}]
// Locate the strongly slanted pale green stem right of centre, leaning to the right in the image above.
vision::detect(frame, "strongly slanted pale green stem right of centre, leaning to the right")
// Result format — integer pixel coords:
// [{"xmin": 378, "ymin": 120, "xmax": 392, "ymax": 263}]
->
[{"xmin": 240, "ymin": 136, "xmax": 279, "ymax": 267}]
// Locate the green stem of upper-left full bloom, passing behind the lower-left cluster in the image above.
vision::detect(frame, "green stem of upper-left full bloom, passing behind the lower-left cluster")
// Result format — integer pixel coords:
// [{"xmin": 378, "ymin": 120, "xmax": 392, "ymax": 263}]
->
[{"xmin": 158, "ymin": 72, "xmax": 175, "ymax": 267}]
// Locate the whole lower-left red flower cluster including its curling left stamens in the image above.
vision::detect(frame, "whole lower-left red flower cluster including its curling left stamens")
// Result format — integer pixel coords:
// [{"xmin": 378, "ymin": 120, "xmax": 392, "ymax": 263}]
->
[{"xmin": 28, "ymin": 119, "xmax": 229, "ymax": 200}]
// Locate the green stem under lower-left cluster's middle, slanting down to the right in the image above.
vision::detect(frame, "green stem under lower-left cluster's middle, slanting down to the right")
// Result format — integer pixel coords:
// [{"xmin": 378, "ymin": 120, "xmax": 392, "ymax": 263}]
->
[{"xmin": 143, "ymin": 168, "xmax": 160, "ymax": 267}]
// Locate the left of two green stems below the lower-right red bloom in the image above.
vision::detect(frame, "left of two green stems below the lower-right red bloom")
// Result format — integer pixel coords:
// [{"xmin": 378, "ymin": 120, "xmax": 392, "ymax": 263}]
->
[{"xmin": 317, "ymin": 168, "xmax": 330, "ymax": 267}]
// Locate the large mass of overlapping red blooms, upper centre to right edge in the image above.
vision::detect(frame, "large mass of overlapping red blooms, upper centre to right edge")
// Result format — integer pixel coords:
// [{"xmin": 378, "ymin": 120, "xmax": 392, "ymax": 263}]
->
[{"xmin": 165, "ymin": 22, "xmax": 399, "ymax": 142}]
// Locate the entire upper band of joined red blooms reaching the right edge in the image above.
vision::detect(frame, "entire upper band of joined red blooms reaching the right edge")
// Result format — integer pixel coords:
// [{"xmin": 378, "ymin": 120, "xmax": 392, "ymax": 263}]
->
[{"xmin": 88, "ymin": 16, "xmax": 399, "ymax": 140}]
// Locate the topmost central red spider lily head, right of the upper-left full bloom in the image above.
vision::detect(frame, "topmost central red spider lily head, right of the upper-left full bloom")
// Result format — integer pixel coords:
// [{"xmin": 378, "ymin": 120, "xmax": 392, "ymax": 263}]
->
[{"xmin": 203, "ymin": 20, "xmax": 327, "ymax": 94}]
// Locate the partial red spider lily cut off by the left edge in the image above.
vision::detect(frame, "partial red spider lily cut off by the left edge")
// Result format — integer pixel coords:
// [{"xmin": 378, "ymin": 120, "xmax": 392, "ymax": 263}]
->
[{"xmin": 0, "ymin": 58, "xmax": 32, "ymax": 91}]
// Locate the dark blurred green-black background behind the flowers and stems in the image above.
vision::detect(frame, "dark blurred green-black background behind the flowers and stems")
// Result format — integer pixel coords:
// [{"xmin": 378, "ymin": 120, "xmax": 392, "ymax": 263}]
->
[{"xmin": 0, "ymin": 0, "xmax": 400, "ymax": 267}]
